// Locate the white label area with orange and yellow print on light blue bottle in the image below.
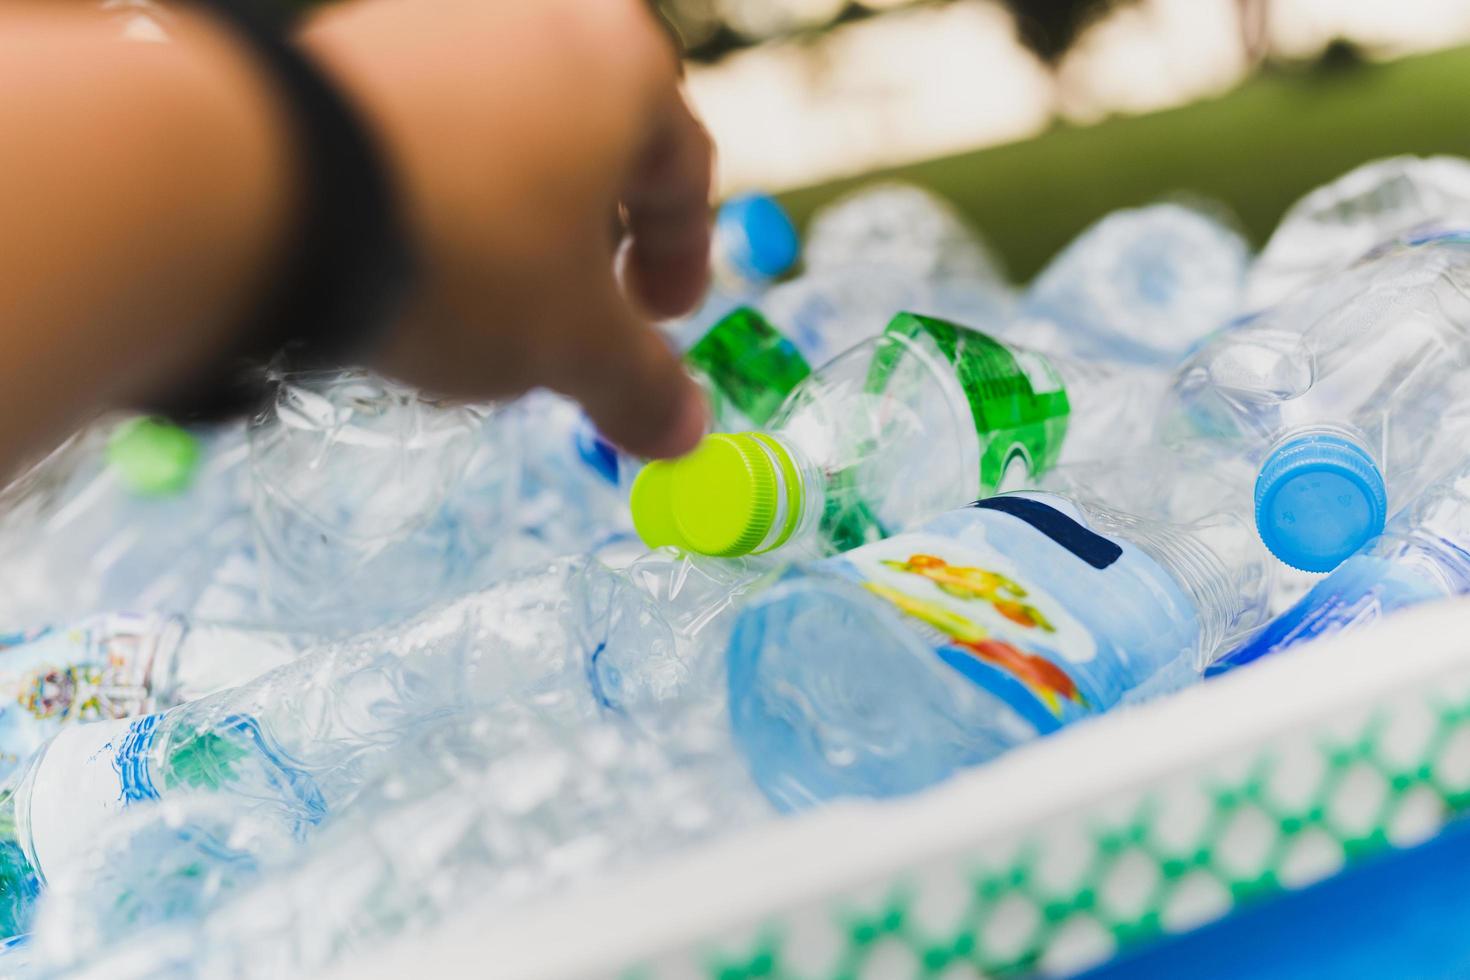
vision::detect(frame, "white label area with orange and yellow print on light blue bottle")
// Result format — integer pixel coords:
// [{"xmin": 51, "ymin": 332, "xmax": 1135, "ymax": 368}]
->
[{"xmin": 832, "ymin": 505, "xmax": 1107, "ymax": 735}]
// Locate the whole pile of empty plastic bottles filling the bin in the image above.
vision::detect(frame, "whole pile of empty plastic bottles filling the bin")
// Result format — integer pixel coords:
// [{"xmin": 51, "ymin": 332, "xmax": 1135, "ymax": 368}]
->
[{"xmin": 0, "ymin": 157, "xmax": 1470, "ymax": 977}]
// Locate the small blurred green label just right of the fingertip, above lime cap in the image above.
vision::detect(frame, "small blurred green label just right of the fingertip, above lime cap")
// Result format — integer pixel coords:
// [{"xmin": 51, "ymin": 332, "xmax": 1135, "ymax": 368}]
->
[{"xmin": 684, "ymin": 307, "xmax": 811, "ymax": 428}]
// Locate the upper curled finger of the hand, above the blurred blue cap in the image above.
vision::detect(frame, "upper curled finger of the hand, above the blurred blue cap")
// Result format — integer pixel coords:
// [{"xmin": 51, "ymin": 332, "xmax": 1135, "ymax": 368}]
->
[{"xmin": 620, "ymin": 84, "xmax": 714, "ymax": 317}]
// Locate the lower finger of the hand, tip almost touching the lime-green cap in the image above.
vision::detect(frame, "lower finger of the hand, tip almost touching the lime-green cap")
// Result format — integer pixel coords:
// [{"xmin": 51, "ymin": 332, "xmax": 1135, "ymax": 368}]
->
[{"xmin": 551, "ymin": 282, "xmax": 707, "ymax": 458}]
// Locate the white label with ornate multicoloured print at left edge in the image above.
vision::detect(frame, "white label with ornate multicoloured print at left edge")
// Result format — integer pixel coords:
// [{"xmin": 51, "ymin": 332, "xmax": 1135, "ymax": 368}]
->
[{"xmin": 0, "ymin": 614, "xmax": 184, "ymax": 773}]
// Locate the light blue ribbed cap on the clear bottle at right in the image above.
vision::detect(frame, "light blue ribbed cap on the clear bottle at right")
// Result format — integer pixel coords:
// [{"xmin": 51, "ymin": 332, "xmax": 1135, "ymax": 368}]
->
[{"xmin": 1255, "ymin": 433, "xmax": 1388, "ymax": 572}]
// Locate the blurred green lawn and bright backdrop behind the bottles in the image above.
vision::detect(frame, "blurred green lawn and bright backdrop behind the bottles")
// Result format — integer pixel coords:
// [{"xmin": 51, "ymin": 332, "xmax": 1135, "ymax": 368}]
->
[{"xmin": 657, "ymin": 0, "xmax": 1470, "ymax": 278}]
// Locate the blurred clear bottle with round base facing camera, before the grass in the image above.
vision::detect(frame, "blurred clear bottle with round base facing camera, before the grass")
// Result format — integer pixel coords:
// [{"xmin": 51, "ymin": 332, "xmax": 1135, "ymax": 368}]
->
[{"xmin": 1007, "ymin": 204, "xmax": 1250, "ymax": 367}]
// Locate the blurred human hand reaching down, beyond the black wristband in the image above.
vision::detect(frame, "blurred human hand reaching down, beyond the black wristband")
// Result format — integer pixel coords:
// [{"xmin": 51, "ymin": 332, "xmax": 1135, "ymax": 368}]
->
[{"xmin": 301, "ymin": 0, "xmax": 711, "ymax": 457}]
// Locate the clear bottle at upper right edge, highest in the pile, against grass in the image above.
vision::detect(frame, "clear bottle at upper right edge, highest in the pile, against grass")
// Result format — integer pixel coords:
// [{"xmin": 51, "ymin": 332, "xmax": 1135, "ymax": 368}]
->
[{"xmin": 1248, "ymin": 156, "xmax": 1470, "ymax": 310}]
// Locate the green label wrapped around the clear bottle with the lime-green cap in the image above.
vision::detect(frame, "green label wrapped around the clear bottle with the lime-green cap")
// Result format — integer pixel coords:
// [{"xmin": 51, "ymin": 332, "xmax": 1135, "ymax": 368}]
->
[{"xmin": 869, "ymin": 313, "xmax": 1072, "ymax": 492}]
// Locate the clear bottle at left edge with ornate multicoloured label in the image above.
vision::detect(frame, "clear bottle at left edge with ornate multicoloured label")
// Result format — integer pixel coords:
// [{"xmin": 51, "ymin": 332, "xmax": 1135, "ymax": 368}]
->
[{"xmin": 0, "ymin": 613, "xmax": 297, "ymax": 777}]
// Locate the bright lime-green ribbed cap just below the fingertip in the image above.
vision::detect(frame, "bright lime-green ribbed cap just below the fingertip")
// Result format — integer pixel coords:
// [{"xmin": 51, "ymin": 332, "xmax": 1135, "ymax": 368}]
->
[{"xmin": 632, "ymin": 432, "xmax": 803, "ymax": 558}]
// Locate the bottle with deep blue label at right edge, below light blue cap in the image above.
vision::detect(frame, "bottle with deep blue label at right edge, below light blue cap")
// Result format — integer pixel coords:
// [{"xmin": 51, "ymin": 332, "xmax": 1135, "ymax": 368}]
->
[{"xmin": 1208, "ymin": 469, "xmax": 1470, "ymax": 674}]
